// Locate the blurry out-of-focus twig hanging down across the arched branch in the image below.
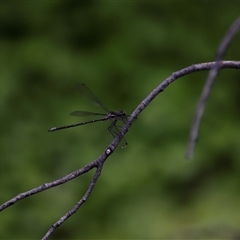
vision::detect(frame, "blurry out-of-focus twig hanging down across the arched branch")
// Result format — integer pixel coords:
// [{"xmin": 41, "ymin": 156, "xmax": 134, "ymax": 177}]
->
[{"xmin": 186, "ymin": 17, "xmax": 240, "ymax": 158}]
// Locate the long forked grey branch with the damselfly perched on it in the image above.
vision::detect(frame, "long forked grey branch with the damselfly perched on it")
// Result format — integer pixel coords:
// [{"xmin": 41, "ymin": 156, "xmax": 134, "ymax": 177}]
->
[{"xmin": 0, "ymin": 61, "xmax": 240, "ymax": 239}]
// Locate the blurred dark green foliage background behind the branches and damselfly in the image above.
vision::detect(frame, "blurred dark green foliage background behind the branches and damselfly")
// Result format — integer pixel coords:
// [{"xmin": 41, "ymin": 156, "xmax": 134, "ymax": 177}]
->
[{"xmin": 0, "ymin": 1, "xmax": 240, "ymax": 239}]
